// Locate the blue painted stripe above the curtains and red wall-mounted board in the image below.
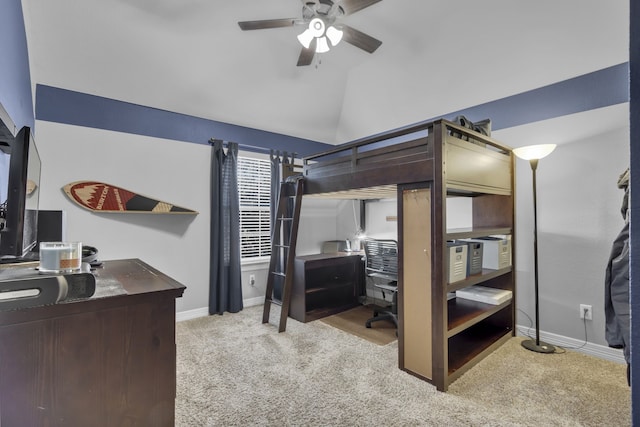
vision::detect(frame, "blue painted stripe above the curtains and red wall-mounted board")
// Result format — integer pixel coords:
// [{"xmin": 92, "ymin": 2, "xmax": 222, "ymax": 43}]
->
[{"xmin": 36, "ymin": 84, "xmax": 331, "ymax": 157}]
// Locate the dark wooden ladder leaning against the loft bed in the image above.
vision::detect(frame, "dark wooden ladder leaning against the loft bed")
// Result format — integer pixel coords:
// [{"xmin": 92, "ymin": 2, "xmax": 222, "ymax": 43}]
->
[{"xmin": 262, "ymin": 175, "xmax": 304, "ymax": 332}]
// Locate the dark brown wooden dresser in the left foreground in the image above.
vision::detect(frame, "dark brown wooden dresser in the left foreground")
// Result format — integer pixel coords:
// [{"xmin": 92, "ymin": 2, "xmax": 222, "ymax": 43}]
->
[{"xmin": 0, "ymin": 259, "xmax": 185, "ymax": 426}]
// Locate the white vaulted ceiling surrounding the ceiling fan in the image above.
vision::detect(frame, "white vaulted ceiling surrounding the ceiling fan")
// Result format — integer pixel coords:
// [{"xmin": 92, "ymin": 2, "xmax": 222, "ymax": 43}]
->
[{"xmin": 22, "ymin": 0, "xmax": 629, "ymax": 144}]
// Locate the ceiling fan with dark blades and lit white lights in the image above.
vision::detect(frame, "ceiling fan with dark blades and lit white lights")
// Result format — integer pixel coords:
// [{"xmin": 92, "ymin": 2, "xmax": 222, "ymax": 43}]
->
[{"xmin": 238, "ymin": 0, "xmax": 382, "ymax": 66}]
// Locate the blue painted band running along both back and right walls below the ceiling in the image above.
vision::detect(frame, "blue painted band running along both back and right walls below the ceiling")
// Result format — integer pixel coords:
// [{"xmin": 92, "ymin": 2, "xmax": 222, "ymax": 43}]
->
[{"xmin": 36, "ymin": 62, "xmax": 629, "ymax": 156}]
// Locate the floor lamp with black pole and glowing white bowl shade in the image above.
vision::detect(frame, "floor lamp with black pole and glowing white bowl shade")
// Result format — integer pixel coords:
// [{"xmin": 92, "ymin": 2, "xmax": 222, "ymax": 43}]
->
[{"xmin": 513, "ymin": 144, "xmax": 556, "ymax": 353}]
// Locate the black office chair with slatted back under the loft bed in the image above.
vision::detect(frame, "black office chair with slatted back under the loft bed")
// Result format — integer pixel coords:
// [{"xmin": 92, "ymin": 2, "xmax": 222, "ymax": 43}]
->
[{"xmin": 364, "ymin": 239, "xmax": 398, "ymax": 329}]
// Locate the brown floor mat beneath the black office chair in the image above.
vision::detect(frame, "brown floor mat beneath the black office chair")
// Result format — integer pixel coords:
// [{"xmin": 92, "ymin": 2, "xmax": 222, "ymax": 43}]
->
[{"xmin": 320, "ymin": 305, "xmax": 397, "ymax": 345}]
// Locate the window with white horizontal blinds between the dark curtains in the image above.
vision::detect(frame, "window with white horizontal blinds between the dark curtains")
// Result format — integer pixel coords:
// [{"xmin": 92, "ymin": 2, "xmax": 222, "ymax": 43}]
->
[{"xmin": 238, "ymin": 157, "xmax": 271, "ymax": 259}]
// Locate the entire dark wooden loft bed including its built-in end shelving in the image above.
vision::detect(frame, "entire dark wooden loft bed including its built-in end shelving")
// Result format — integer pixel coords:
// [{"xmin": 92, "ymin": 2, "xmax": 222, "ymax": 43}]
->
[{"xmin": 303, "ymin": 119, "xmax": 515, "ymax": 391}]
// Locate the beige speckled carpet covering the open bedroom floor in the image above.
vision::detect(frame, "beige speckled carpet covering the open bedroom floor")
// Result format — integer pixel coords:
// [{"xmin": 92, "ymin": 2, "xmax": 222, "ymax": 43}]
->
[{"xmin": 176, "ymin": 307, "xmax": 631, "ymax": 427}]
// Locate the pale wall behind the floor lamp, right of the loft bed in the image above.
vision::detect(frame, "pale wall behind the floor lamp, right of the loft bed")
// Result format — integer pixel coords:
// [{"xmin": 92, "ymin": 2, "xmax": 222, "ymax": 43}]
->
[{"xmin": 500, "ymin": 128, "xmax": 629, "ymax": 345}]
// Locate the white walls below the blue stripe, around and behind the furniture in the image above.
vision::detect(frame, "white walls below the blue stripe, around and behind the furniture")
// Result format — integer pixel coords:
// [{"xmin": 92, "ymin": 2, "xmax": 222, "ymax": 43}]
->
[{"xmin": 37, "ymin": 114, "xmax": 629, "ymax": 352}]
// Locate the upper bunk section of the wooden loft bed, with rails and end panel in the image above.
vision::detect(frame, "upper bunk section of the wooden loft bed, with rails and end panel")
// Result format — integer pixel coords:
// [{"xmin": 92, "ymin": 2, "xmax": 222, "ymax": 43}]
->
[{"xmin": 303, "ymin": 119, "xmax": 511, "ymax": 197}]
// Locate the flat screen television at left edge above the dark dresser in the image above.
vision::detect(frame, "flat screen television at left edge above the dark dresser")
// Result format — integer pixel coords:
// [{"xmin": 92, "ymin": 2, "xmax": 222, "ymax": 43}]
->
[{"xmin": 0, "ymin": 126, "xmax": 41, "ymax": 262}]
